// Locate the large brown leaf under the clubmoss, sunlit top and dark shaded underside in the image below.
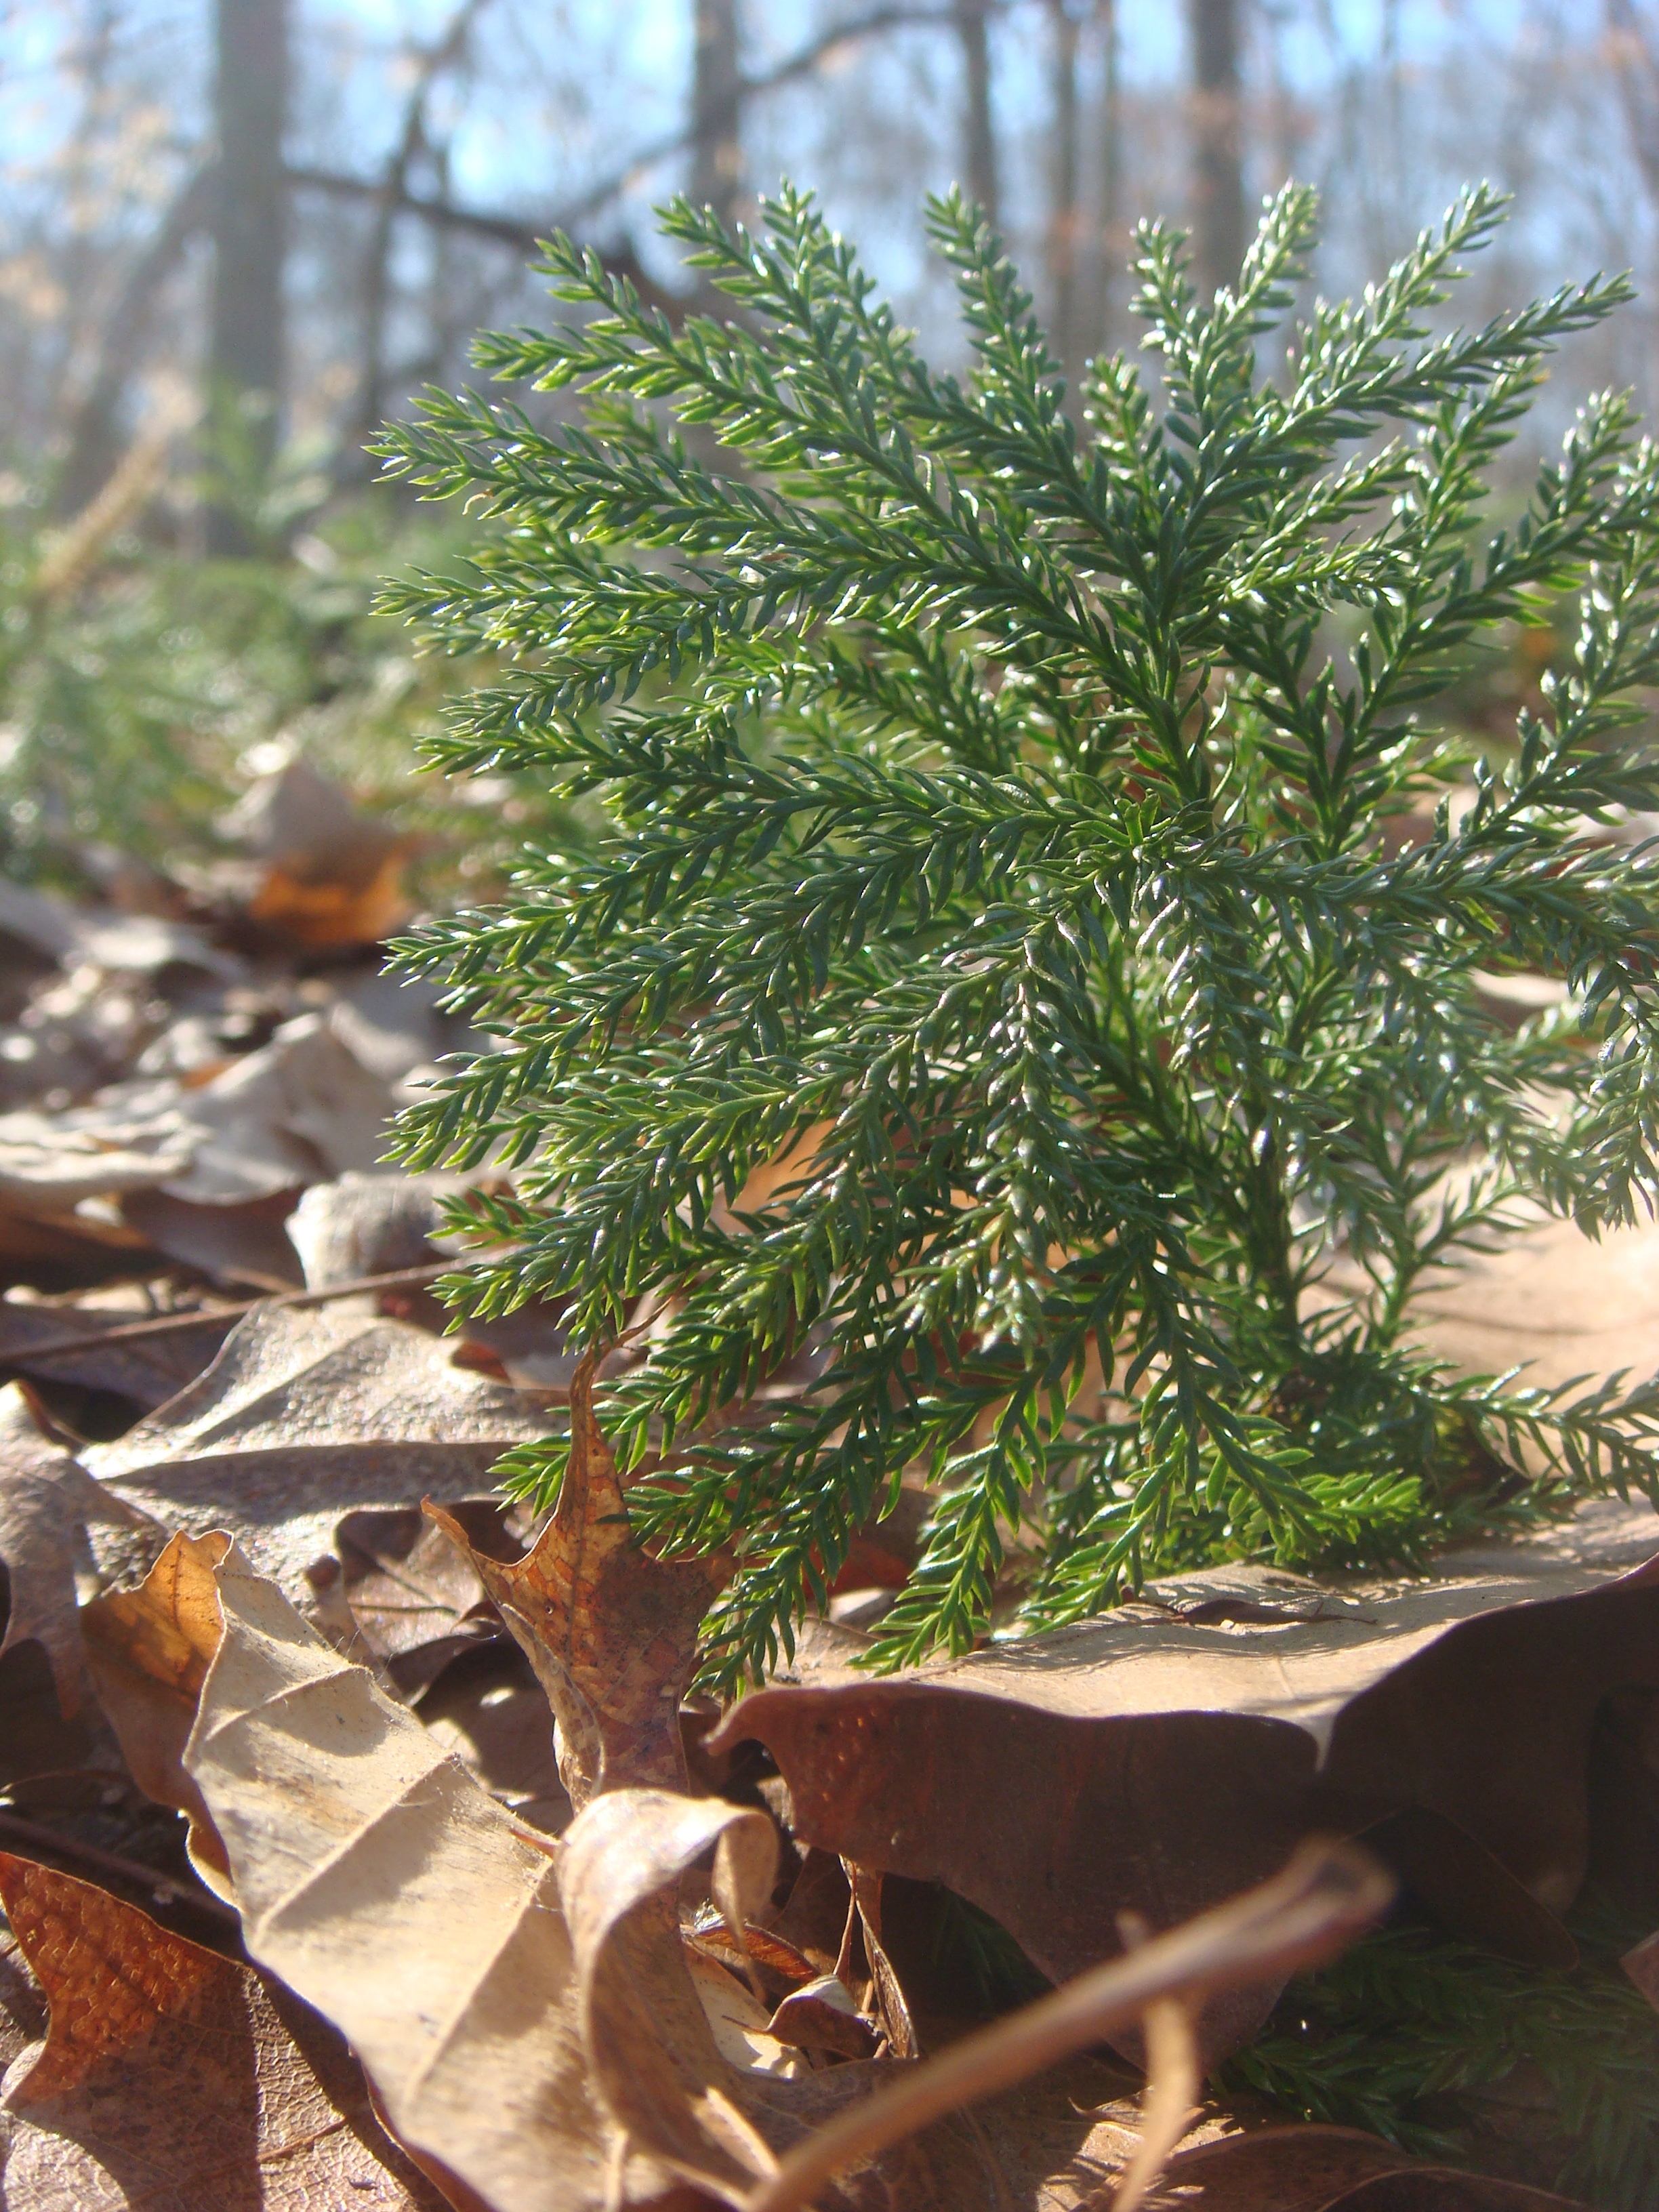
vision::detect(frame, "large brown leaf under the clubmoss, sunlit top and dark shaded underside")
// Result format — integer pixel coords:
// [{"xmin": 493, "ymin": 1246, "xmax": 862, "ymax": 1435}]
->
[{"xmin": 710, "ymin": 1500, "xmax": 1659, "ymax": 2057}]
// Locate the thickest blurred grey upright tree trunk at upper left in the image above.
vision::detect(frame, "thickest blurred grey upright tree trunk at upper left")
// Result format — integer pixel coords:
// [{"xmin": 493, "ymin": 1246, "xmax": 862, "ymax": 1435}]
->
[{"xmin": 208, "ymin": 0, "xmax": 287, "ymax": 553}]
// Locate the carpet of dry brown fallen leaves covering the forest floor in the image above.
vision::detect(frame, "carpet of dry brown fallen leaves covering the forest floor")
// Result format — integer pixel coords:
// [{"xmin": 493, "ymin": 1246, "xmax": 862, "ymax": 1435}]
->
[{"xmin": 0, "ymin": 772, "xmax": 1659, "ymax": 2212}]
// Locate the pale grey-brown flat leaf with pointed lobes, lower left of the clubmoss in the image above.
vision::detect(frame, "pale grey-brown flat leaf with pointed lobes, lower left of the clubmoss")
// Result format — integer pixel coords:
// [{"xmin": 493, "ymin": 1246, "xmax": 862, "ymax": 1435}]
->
[{"xmin": 84, "ymin": 1305, "xmax": 544, "ymax": 1606}]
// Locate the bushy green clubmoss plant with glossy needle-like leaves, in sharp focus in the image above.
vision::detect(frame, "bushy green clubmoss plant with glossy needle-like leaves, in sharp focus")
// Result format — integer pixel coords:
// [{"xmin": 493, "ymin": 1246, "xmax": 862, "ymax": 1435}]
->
[{"xmin": 383, "ymin": 188, "xmax": 1659, "ymax": 1683}]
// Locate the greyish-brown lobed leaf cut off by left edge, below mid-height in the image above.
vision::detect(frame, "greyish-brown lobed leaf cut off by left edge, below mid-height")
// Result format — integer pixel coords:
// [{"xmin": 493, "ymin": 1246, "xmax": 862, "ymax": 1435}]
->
[{"xmin": 0, "ymin": 1382, "xmax": 161, "ymax": 1719}]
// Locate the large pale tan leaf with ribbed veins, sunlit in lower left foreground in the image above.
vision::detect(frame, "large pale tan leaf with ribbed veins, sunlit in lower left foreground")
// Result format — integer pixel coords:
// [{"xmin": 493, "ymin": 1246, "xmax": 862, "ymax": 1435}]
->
[{"xmin": 184, "ymin": 1551, "xmax": 641, "ymax": 2212}]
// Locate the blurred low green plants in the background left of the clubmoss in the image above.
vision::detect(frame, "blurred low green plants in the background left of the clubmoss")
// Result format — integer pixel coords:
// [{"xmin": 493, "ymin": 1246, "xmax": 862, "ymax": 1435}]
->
[{"xmin": 0, "ymin": 457, "xmax": 562, "ymax": 903}]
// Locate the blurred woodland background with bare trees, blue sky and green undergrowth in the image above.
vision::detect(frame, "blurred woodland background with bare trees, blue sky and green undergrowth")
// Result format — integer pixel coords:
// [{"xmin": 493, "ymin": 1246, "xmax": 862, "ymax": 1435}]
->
[{"xmin": 0, "ymin": 0, "xmax": 1659, "ymax": 903}]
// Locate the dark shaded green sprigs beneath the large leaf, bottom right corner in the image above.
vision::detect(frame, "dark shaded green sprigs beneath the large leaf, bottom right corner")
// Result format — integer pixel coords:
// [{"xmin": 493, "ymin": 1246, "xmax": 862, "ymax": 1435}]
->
[{"xmin": 1221, "ymin": 1913, "xmax": 1659, "ymax": 2212}]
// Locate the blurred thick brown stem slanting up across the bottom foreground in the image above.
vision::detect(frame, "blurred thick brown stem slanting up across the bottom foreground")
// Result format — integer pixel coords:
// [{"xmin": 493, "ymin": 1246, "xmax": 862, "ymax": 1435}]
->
[{"xmin": 743, "ymin": 1841, "xmax": 1393, "ymax": 2212}]
